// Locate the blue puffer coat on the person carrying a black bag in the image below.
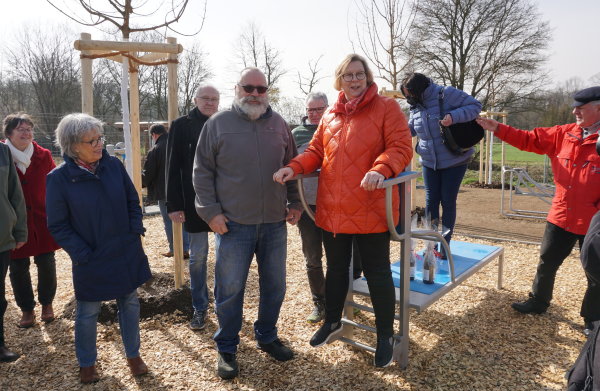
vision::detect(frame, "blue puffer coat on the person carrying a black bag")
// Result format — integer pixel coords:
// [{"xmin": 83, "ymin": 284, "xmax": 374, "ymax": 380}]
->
[{"xmin": 408, "ymin": 83, "xmax": 481, "ymax": 170}]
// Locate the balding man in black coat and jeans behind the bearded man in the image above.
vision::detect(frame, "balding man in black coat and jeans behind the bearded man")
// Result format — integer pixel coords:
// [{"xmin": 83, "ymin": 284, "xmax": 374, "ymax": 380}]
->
[{"xmin": 166, "ymin": 84, "xmax": 219, "ymax": 330}]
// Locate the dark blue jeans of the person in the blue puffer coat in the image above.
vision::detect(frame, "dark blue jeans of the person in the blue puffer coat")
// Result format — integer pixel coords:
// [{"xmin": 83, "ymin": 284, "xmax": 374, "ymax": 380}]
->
[{"xmin": 423, "ymin": 164, "xmax": 467, "ymax": 242}]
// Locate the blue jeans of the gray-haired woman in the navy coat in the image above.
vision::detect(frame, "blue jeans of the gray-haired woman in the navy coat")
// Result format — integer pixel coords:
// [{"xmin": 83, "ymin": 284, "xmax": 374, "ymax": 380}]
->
[{"xmin": 75, "ymin": 290, "xmax": 140, "ymax": 367}]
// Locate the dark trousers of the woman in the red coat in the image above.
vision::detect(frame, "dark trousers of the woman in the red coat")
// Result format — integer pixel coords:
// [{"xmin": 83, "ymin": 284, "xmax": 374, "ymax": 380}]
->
[{"xmin": 10, "ymin": 251, "xmax": 56, "ymax": 311}]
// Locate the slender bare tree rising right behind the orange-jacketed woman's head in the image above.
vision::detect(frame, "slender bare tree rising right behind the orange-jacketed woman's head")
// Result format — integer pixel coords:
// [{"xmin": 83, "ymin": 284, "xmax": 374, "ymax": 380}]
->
[{"xmin": 352, "ymin": 0, "xmax": 415, "ymax": 90}]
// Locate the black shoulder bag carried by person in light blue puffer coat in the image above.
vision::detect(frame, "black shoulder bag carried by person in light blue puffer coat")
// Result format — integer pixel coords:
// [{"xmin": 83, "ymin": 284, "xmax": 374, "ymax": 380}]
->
[{"xmin": 438, "ymin": 87, "xmax": 485, "ymax": 155}]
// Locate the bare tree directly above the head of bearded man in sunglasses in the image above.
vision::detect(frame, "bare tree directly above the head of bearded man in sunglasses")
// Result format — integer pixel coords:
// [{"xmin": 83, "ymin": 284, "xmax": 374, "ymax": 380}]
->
[{"xmin": 236, "ymin": 22, "xmax": 287, "ymax": 102}]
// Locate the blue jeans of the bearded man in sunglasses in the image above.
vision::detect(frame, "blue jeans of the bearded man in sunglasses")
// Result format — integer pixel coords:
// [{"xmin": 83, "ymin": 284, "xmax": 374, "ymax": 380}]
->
[{"xmin": 214, "ymin": 221, "xmax": 287, "ymax": 353}]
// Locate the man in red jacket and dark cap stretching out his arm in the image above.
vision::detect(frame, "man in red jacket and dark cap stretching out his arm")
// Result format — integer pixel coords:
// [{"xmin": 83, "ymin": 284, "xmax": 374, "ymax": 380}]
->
[{"xmin": 477, "ymin": 86, "xmax": 600, "ymax": 332}]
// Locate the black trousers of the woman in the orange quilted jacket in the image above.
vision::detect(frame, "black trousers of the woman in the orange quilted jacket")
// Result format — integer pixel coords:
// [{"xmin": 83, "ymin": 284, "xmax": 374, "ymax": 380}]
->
[{"xmin": 323, "ymin": 231, "xmax": 395, "ymax": 337}]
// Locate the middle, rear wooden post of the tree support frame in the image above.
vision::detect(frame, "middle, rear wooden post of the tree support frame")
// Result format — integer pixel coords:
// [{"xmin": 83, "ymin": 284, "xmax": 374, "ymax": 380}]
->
[{"xmin": 127, "ymin": 63, "xmax": 144, "ymax": 210}]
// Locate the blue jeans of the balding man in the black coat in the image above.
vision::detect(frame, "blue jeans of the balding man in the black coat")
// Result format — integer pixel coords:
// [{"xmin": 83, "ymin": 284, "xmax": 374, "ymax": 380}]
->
[{"xmin": 188, "ymin": 232, "xmax": 208, "ymax": 311}]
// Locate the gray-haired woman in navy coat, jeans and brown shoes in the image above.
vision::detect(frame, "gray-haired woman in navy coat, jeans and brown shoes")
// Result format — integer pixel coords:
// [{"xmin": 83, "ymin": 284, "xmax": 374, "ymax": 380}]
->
[{"xmin": 46, "ymin": 114, "xmax": 151, "ymax": 383}]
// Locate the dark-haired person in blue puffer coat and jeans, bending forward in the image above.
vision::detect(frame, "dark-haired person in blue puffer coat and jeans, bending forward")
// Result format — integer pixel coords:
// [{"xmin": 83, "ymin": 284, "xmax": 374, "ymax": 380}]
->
[{"xmin": 402, "ymin": 72, "xmax": 481, "ymax": 258}]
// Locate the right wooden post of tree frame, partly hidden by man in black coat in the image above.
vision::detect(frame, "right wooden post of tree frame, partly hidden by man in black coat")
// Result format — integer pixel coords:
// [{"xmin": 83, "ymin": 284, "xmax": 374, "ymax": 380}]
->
[{"xmin": 167, "ymin": 37, "xmax": 183, "ymax": 289}]
